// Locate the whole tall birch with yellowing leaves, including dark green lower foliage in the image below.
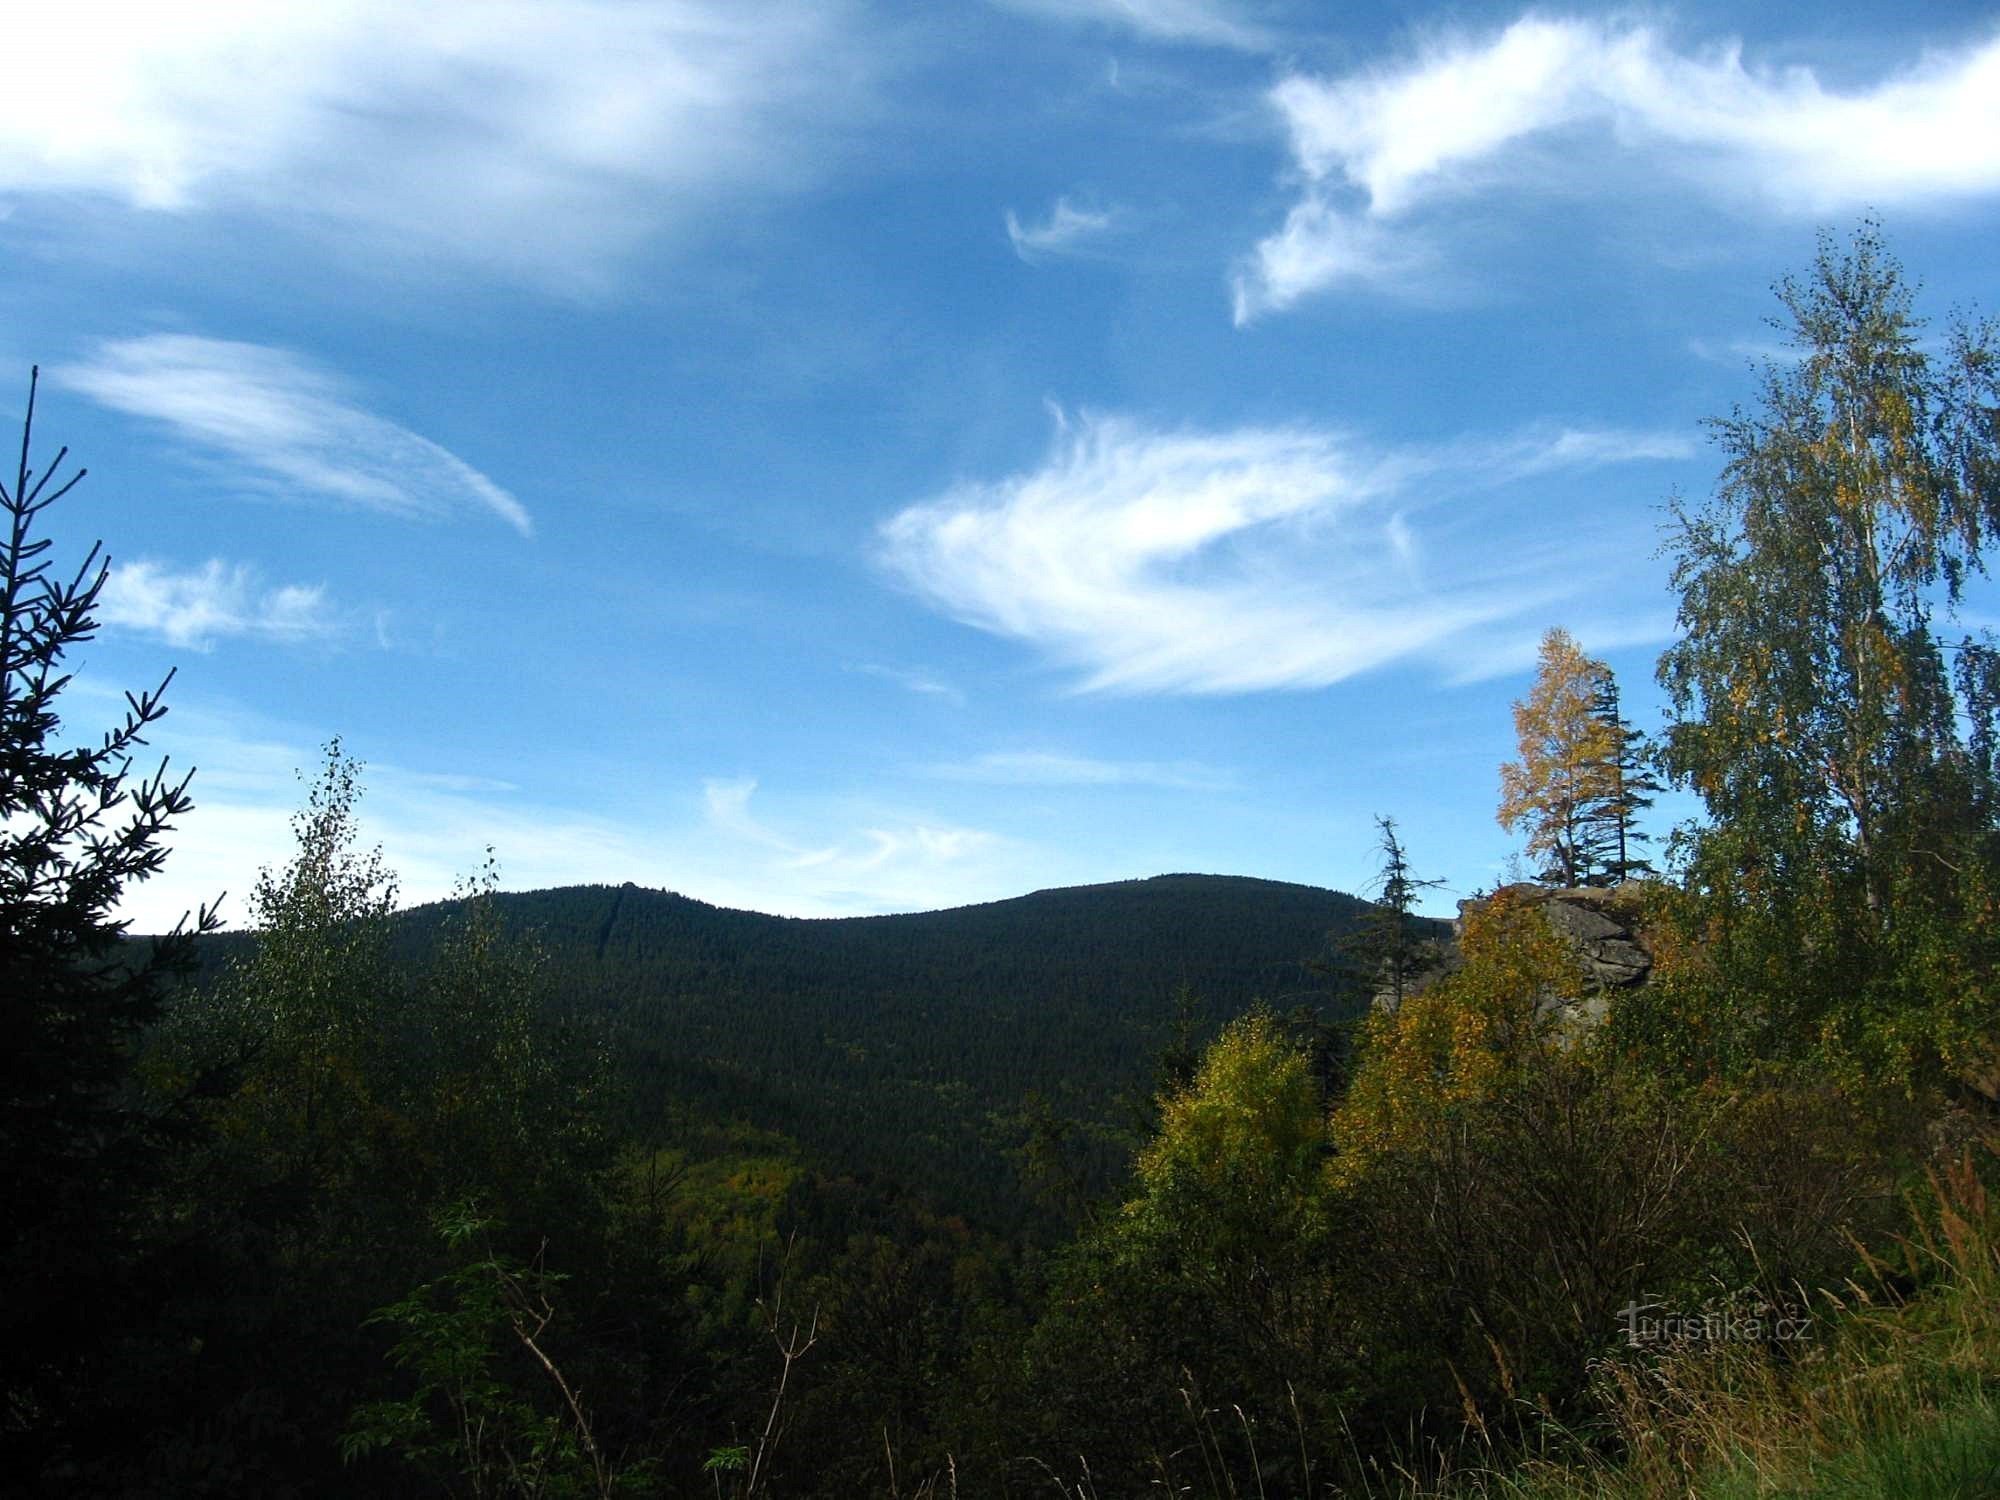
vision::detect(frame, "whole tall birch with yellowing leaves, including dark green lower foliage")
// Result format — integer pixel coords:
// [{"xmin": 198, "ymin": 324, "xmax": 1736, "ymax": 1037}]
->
[{"xmin": 1660, "ymin": 226, "xmax": 2000, "ymax": 1082}]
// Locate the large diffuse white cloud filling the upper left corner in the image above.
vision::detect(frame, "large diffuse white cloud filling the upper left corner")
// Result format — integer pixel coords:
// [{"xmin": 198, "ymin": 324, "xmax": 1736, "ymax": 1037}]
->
[{"xmin": 0, "ymin": 0, "xmax": 866, "ymax": 282}]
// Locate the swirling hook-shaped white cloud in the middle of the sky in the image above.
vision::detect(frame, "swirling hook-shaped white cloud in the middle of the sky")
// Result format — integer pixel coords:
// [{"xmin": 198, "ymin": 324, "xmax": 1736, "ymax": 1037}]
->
[{"xmin": 882, "ymin": 418, "xmax": 1430, "ymax": 692}]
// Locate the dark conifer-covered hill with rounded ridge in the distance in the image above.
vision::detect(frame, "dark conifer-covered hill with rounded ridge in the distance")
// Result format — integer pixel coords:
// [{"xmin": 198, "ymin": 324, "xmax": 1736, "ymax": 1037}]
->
[{"xmin": 378, "ymin": 874, "xmax": 1392, "ymax": 1220}]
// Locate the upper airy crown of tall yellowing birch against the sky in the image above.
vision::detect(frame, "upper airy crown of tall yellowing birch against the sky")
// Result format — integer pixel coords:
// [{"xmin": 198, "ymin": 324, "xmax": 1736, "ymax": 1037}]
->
[{"xmin": 1660, "ymin": 226, "xmax": 2000, "ymax": 928}]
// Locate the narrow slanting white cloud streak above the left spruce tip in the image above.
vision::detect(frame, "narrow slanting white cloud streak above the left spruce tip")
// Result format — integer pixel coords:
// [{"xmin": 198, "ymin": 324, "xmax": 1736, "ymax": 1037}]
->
[{"xmin": 56, "ymin": 334, "xmax": 534, "ymax": 536}]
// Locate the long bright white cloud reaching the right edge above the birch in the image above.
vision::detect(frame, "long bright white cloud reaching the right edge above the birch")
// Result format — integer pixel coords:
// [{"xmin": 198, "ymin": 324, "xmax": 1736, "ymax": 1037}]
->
[{"xmin": 1236, "ymin": 14, "xmax": 2000, "ymax": 322}]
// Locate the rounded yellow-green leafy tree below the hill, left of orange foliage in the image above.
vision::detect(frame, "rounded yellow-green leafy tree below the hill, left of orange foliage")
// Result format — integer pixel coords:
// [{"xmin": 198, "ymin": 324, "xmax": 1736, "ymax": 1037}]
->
[{"xmin": 1008, "ymin": 1010, "xmax": 1362, "ymax": 1492}]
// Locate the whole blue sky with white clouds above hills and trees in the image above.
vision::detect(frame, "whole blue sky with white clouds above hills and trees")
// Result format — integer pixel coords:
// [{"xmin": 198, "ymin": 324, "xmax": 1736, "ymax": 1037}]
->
[{"xmin": 0, "ymin": 0, "xmax": 2000, "ymax": 928}]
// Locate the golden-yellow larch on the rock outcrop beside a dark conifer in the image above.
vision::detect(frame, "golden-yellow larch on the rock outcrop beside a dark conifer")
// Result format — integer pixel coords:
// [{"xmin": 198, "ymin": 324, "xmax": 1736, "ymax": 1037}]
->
[{"xmin": 1498, "ymin": 626, "xmax": 1620, "ymax": 886}]
